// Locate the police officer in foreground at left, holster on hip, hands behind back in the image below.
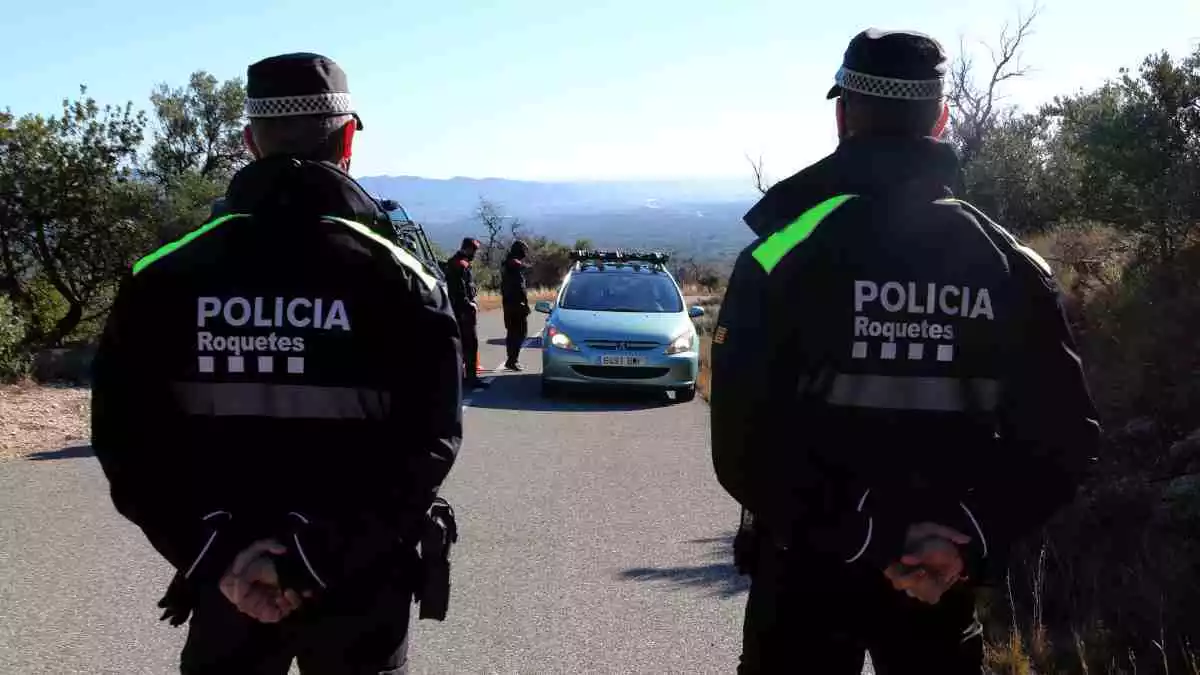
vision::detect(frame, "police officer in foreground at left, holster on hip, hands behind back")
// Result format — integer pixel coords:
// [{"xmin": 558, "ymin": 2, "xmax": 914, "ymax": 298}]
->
[{"xmin": 92, "ymin": 54, "xmax": 462, "ymax": 675}]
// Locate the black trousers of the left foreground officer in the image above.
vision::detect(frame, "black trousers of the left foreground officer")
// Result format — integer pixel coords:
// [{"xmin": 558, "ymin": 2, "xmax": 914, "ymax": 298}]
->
[{"xmin": 180, "ymin": 566, "xmax": 413, "ymax": 675}]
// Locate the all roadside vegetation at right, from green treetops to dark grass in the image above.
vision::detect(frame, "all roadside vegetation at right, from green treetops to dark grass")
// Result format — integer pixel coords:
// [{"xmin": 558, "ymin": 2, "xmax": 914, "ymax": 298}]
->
[{"xmin": 966, "ymin": 50, "xmax": 1200, "ymax": 674}]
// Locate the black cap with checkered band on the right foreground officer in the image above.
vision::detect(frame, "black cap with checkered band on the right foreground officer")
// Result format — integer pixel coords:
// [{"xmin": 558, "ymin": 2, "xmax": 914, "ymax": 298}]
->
[{"xmin": 826, "ymin": 28, "xmax": 947, "ymax": 101}]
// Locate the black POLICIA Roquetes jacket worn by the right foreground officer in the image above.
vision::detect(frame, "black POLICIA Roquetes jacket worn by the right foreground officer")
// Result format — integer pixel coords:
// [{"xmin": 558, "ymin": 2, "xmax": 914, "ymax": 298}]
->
[{"xmin": 710, "ymin": 138, "xmax": 1099, "ymax": 574}]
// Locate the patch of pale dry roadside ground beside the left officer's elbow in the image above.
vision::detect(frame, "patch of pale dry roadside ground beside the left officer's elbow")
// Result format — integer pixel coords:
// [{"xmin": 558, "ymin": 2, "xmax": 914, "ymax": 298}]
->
[{"xmin": 0, "ymin": 383, "xmax": 91, "ymax": 461}]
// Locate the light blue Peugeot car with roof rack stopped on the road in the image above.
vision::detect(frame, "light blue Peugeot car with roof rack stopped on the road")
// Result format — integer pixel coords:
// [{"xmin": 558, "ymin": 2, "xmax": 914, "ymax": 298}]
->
[{"xmin": 534, "ymin": 251, "xmax": 704, "ymax": 402}]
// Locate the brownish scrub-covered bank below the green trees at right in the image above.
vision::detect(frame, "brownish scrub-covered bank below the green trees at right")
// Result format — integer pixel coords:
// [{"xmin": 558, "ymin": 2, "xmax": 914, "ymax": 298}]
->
[{"xmin": 988, "ymin": 229, "xmax": 1200, "ymax": 674}]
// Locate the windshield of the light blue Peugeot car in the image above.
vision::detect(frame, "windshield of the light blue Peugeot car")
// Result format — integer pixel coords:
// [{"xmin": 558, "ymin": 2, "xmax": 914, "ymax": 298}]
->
[{"xmin": 559, "ymin": 273, "xmax": 683, "ymax": 313}]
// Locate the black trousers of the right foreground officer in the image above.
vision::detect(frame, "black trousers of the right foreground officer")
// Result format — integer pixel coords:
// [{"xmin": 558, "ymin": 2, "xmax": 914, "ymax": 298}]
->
[{"xmin": 738, "ymin": 535, "xmax": 983, "ymax": 675}]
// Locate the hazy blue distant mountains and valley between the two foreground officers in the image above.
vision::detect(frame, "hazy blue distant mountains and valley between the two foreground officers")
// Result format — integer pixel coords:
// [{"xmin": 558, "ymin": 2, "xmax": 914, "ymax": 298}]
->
[{"xmin": 358, "ymin": 175, "xmax": 758, "ymax": 259}]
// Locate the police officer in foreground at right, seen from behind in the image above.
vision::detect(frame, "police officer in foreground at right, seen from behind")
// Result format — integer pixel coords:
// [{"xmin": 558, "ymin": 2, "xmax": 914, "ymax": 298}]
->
[{"xmin": 712, "ymin": 30, "xmax": 1099, "ymax": 675}]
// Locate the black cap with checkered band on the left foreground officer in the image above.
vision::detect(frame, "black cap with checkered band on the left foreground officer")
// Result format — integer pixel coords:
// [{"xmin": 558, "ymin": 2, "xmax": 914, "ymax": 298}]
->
[{"xmin": 246, "ymin": 52, "xmax": 362, "ymax": 130}]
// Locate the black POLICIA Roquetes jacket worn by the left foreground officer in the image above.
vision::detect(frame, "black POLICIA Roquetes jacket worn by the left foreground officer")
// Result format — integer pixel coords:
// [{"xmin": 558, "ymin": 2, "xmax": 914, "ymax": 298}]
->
[{"xmin": 91, "ymin": 160, "xmax": 462, "ymax": 591}]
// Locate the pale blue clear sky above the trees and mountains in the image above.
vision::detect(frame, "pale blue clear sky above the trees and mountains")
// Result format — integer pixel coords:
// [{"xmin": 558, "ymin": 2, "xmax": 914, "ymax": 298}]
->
[{"xmin": 0, "ymin": 0, "xmax": 1200, "ymax": 179}]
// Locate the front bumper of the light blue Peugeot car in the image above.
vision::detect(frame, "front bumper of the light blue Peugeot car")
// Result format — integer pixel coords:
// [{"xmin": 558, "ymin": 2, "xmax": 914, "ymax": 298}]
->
[{"xmin": 541, "ymin": 345, "xmax": 700, "ymax": 389}]
